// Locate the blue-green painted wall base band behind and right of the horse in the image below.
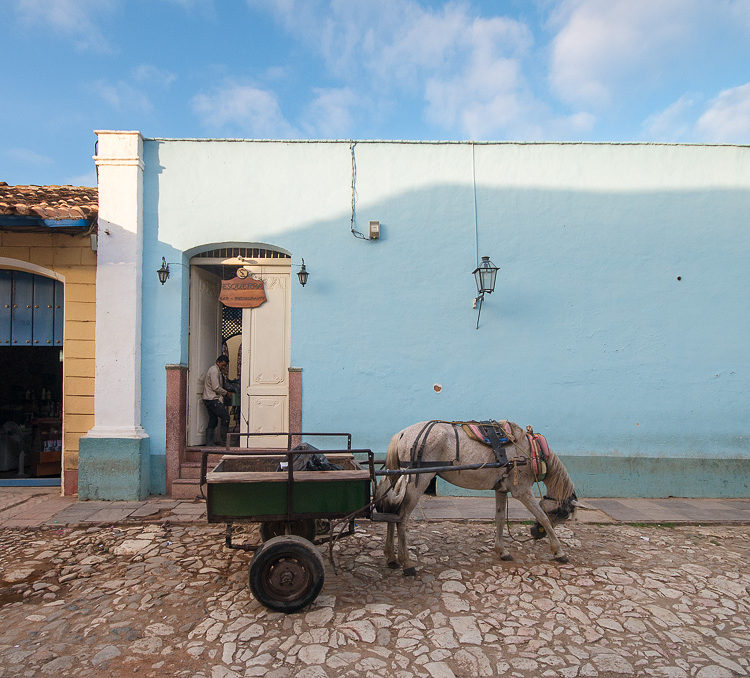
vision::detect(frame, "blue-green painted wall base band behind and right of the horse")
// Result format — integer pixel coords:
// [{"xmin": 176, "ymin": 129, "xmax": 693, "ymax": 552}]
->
[{"xmin": 436, "ymin": 455, "xmax": 750, "ymax": 498}]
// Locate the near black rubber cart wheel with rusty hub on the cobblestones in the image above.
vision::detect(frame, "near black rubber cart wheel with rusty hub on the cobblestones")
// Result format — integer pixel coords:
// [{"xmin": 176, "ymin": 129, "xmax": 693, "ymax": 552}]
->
[{"xmin": 250, "ymin": 535, "xmax": 325, "ymax": 613}]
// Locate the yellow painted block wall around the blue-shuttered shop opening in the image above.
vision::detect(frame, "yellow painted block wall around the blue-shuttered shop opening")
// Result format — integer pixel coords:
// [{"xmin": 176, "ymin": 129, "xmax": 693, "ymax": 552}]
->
[{"xmin": 0, "ymin": 232, "xmax": 96, "ymax": 480}]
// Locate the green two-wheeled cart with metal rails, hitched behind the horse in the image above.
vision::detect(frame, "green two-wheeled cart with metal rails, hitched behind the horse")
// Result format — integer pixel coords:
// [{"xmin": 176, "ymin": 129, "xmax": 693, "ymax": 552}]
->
[{"xmin": 201, "ymin": 433, "xmax": 375, "ymax": 612}]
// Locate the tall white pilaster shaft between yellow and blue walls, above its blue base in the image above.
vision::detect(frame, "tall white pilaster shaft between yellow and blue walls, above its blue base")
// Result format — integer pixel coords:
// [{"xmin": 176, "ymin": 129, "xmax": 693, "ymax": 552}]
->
[{"xmin": 88, "ymin": 131, "xmax": 145, "ymax": 438}]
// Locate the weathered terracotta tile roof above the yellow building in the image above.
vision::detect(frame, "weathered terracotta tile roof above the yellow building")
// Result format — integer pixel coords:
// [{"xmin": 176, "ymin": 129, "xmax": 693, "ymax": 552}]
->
[{"xmin": 0, "ymin": 181, "xmax": 99, "ymax": 221}]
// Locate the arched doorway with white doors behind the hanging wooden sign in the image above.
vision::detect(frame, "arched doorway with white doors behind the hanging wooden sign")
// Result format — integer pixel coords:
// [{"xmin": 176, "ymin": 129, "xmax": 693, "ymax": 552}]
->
[{"xmin": 187, "ymin": 245, "xmax": 291, "ymax": 447}]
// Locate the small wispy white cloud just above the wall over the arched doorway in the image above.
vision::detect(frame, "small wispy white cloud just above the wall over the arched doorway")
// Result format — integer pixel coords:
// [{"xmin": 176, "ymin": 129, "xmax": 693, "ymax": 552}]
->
[{"xmin": 192, "ymin": 84, "xmax": 299, "ymax": 138}]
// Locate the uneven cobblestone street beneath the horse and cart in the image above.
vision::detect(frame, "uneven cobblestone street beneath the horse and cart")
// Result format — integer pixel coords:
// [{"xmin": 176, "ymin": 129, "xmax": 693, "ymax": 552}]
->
[{"xmin": 0, "ymin": 522, "xmax": 750, "ymax": 678}]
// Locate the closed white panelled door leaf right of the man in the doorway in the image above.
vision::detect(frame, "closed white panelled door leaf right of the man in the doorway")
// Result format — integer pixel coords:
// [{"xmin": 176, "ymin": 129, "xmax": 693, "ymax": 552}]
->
[{"xmin": 241, "ymin": 263, "xmax": 290, "ymax": 447}]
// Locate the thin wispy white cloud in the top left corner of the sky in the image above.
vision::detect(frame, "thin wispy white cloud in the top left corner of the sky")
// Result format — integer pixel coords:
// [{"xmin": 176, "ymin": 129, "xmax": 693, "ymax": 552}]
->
[{"xmin": 16, "ymin": 0, "xmax": 116, "ymax": 53}]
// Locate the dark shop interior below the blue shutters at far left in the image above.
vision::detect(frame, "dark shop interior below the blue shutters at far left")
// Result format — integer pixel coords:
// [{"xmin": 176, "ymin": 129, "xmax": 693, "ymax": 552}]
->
[{"xmin": 0, "ymin": 346, "xmax": 63, "ymax": 480}]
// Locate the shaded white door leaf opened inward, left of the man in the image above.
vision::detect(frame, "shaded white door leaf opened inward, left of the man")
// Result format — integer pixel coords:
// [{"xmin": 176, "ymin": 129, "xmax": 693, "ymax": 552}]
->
[{"xmin": 187, "ymin": 266, "xmax": 221, "ymax": 445}]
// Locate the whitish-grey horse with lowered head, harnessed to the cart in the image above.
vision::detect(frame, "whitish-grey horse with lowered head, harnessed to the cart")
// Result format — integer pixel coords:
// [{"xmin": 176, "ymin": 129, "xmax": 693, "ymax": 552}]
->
[{"xmin": 374, "ymin": 421, "xmax": 577, "ymax": 576}]
